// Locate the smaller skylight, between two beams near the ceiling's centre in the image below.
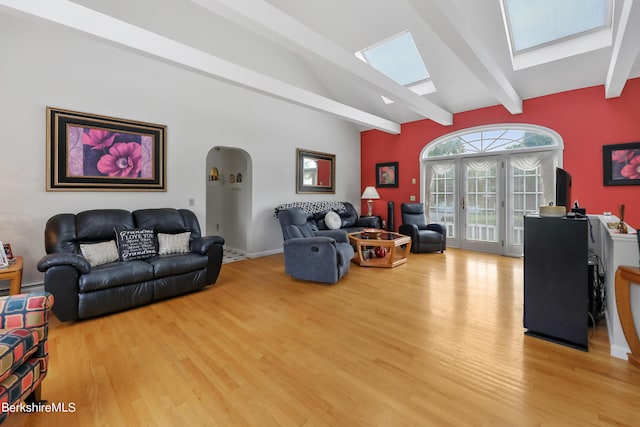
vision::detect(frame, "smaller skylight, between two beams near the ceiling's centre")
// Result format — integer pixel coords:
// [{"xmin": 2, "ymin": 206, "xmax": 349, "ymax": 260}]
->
[{"xmin": 356, "ymin": 31, "xmax": 429, "ymax": 86}]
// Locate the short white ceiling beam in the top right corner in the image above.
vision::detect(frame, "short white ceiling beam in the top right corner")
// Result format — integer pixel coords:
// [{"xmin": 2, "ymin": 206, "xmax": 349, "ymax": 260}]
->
[{"xmin": 604, "ymin": 0, "xmax": 640, "ymax": 98}]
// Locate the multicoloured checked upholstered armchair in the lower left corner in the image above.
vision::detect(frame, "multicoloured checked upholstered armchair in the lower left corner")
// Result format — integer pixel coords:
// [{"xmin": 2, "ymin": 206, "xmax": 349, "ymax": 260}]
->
[{"xmin": 0, "ymin": 292, "xmax": 53, "ymax": 423}]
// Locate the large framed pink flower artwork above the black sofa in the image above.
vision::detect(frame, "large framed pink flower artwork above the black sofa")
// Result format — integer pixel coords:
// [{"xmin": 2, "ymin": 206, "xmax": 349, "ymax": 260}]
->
[{"xmin": 47, "ymin": 107, "xmax": 167, "ymax": 191}]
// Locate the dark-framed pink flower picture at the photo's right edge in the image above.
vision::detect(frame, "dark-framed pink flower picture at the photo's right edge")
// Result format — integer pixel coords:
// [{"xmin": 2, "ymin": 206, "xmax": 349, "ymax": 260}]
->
[{"xmin": 602, "ymin": 142, "xmax": 640, "ymax": 185}]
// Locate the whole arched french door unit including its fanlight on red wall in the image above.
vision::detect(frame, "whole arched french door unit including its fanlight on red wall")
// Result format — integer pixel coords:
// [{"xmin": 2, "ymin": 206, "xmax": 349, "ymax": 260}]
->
[{"xmin": 421, "ymin": 124, "xmax": 563, "ymax": 256}]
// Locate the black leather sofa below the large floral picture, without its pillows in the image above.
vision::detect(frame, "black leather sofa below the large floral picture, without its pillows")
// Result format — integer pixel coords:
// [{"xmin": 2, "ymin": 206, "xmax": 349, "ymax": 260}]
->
[{"xmin": 38, "ymin": 208, "xmax": 224, "ymax": 321}]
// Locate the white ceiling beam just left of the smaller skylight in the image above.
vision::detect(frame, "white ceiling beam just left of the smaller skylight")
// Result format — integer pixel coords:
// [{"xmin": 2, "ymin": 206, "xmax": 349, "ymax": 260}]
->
[{"xmin": 191, "ymin": 0, "xmax": 453, "ymax": 125}]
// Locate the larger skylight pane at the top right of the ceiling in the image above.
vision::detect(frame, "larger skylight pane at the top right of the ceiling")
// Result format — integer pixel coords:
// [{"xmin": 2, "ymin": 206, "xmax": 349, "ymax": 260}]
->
[{"xmin": 503, "ymin": 0, "xmax": 612, "ymax": 53}]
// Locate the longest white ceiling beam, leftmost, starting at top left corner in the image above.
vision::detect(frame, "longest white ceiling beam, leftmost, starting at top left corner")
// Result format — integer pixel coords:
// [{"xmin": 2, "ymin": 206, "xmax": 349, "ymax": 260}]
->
[{"xmin": 0, "ymin": 0, "xmax": 400, "ymax": 134}]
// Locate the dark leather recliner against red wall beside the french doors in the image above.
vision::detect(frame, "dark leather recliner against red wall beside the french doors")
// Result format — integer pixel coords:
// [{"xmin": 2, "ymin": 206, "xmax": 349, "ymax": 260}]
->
[{"xmin": 399, "ymin": 203, "xmax": 447, "ymax": 253}]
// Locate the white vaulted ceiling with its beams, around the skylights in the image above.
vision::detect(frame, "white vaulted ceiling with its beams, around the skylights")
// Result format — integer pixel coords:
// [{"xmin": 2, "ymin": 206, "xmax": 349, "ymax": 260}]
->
[{"xmin": 0, "ymin": 0, "xmax": 640, "ymax": 133}]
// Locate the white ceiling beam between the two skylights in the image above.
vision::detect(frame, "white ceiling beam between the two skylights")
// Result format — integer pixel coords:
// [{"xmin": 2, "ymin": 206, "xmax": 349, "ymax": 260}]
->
[{"xmin": 407, "ymin": 0, "xmax": 522, "ymax": 114}]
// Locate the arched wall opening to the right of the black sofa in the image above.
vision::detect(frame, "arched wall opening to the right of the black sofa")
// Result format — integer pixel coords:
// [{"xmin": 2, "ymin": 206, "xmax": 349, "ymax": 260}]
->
[{"xmin": 206, "ymin": 146, "xmax": 253, "ymax": 255}]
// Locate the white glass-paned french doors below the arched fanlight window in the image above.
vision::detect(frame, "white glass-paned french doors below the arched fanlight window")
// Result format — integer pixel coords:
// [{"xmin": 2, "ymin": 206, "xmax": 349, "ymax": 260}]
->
[{"xmin": 423, "ymin": 154, "xmax": 554, "ymax": 256}]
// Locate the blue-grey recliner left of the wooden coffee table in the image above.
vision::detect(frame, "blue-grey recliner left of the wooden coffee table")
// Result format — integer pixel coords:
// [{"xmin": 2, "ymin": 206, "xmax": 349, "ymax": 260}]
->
[{"xmin": 278, "ymin": 207, "xmax": 354, "ymax": 283}]
